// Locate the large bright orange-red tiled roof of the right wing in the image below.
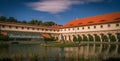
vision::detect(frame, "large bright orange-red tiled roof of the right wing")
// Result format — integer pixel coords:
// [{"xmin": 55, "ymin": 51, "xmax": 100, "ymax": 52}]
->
[{"xmin": 64, "ymin": 12, "xmax": 120, "ymax": 27}]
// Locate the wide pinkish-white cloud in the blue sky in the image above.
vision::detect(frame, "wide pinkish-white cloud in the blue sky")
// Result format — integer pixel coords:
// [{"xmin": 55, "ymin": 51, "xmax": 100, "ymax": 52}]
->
[{"xmin": 25, "ymin": 0, "xmax": 103, "ymax": 14}]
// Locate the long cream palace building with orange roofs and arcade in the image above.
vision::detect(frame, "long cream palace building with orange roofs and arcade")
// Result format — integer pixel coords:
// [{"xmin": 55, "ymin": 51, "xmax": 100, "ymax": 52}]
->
[{"xmin": 0, "ymin": 12, "xmax": 120, "ymax": 42}]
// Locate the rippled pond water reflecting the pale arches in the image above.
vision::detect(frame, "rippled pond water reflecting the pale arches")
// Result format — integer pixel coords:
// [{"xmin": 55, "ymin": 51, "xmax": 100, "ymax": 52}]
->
[{"xmin": 0, "ymin": 44, "xmax": 120, "ymax": 61}]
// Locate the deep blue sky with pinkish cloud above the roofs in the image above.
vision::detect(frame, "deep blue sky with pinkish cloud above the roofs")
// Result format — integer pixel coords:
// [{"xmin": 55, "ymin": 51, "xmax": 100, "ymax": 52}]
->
[{"xmin": 0, "ymin": 0, "xmax": 120, "ymax": 25}]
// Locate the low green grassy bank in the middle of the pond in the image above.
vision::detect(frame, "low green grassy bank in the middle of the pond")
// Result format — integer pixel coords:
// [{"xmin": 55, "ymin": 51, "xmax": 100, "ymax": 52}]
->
[{"xmin": 43, "ymin": 42, "xmax": 77, "ymax": 47}]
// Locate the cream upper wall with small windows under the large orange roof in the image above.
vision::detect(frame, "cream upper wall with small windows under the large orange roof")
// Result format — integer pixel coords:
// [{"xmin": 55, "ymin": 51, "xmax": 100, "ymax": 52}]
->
[{"xmin": 60, "ymin": 22, "xmax": 120, "ymax": 33}]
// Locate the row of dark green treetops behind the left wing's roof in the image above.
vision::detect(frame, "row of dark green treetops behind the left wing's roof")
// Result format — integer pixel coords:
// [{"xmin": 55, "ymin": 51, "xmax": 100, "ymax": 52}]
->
[{"xmin": 0, "ymin": 16, "xmax": 59, "ymax": 26}]
